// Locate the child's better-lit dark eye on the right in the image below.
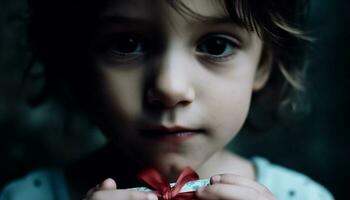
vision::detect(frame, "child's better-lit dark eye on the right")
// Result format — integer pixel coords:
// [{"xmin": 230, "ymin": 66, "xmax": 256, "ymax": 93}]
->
[{"xmin": 196, "ymin": 34, "xmax": 239, "ymax": 59}]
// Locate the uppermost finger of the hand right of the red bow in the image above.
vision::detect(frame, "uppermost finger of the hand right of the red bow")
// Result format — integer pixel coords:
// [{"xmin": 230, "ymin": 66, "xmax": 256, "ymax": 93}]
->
[{"xmin": 210, "ymin": 174, "xmax": 273, "ymax": 196}]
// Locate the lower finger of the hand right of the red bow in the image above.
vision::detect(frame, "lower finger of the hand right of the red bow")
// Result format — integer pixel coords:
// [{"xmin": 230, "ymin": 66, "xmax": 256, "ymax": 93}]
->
[{"xmin": 196, "ymin": 183, "xmax": 269, "ymax": 200}]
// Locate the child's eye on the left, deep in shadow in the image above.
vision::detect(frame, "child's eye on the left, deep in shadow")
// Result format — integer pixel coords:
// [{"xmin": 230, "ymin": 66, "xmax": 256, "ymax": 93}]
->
[{"xmin": 103, "ymin": 33, "xmax": 145, "ymax": 59}]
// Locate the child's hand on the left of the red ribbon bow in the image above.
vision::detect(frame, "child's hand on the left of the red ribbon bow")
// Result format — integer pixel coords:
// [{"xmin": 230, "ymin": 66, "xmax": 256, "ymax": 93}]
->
[{"xmin": 84, "ymin": 178, "xmax": 158, "ymax": 200}]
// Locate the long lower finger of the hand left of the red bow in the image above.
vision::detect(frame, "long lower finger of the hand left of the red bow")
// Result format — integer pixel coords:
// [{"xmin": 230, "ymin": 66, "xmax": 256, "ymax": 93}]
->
[{"xmin": 89, "ymin": 189, "xmax": 158, "ymax": 200}]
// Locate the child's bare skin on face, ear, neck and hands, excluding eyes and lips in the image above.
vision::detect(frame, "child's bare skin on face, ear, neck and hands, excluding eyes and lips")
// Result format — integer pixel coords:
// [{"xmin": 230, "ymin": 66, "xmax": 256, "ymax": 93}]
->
[{"xmin": 81, "ymin": 0, "xmax": 274, "ymax": 200}]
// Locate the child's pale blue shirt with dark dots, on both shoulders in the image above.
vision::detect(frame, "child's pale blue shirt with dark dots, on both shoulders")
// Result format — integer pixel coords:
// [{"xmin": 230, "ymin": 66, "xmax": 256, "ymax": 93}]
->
[{"xmin": 0, "ymin": 157, "xmax": 334, "ymax": 200}]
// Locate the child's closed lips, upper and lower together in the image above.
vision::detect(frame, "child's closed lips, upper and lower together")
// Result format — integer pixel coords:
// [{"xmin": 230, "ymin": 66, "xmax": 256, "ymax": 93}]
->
[{"xmin": 140, "ymin": 126, "xmax": 203, "ymax": 142}]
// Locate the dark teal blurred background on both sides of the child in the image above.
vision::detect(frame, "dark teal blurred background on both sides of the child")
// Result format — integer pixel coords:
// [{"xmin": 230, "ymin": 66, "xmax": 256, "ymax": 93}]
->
[{"xmin": 0, "ymin": 0, "xmax": 350, "ymax": 199}]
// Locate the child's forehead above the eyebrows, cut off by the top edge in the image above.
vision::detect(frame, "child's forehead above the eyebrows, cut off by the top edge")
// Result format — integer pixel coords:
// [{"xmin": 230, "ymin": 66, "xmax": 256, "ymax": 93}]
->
[{"xmin": 102, "ymin": 0, "xmax": 228, "ymax": 21}]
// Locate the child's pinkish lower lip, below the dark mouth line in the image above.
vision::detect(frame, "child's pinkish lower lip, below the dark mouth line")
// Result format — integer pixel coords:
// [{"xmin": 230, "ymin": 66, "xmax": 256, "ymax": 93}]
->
[{"xmin": 140, "ymin": 131, "xmax": 199, "ymax": 143}]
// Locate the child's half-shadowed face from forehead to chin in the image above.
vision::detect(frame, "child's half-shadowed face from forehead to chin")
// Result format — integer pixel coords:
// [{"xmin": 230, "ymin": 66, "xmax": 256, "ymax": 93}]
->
[{"xmin": 89, "ymin": 0, "xmax": 263, "ymax": 173}]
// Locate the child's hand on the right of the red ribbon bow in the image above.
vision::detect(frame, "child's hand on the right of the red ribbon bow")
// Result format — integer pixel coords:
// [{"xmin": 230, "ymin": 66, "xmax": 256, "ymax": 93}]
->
[{"xmin": 196, "ymin": 174, "xmax": 276, "ymax": 200}]
